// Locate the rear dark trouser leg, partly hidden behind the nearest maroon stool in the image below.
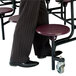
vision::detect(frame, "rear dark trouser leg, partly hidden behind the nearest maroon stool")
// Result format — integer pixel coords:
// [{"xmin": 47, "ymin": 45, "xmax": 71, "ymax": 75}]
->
[{"xmin": 33, "ymin": 1, "xmax": 51, "ymax": 56}]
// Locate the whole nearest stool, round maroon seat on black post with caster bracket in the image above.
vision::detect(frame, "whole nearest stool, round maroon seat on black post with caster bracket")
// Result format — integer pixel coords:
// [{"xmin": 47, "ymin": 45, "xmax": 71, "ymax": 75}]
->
[{"xmin": 36, "ymin": 24, "xmax": 70, "ymax": 73}]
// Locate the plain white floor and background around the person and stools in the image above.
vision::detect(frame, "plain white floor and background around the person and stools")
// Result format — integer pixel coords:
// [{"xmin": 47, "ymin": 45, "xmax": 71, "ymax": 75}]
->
[{"xmin": 0, "ymin": 1, "xmax": 76, "ymax": 76}]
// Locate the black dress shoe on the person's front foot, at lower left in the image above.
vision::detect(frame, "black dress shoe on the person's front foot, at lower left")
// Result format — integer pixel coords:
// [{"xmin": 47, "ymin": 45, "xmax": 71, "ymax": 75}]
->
[{"xmin": 10, "ymin": 60, "xmax": 39, "ymax": 67}]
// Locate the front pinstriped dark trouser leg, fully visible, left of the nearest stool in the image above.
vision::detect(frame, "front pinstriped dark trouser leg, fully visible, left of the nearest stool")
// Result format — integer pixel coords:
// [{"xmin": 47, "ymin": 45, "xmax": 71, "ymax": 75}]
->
[{"xmin": 10, "ymin": 0, "xmax": 40, "ymax": 63}]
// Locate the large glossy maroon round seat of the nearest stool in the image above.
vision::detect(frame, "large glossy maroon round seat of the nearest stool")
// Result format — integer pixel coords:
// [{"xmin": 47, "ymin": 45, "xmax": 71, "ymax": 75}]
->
[{"xmin": 36, "ymin": 24, "xmax": 70, "ymax": 36}]
